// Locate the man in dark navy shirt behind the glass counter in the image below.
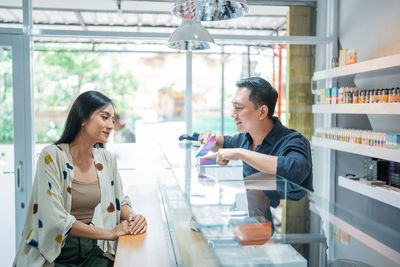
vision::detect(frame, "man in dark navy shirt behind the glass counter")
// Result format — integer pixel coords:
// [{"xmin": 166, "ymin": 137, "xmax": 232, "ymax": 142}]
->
[{"xmin": 199, "ymin": 77, "xmax": 313, "ymax": 191}]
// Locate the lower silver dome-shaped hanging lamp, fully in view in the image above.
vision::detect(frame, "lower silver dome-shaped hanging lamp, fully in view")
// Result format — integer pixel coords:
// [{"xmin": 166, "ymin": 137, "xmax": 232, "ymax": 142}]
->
[{"xmin": 168, "ymin": 19, "xmax": 214, "ymax": 50}]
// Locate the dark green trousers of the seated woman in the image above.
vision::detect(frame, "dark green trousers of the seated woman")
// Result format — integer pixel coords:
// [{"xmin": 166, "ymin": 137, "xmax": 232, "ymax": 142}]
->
[{"xmin": 53, "ymin": 235, "xmax": 114, "ymax": 267}]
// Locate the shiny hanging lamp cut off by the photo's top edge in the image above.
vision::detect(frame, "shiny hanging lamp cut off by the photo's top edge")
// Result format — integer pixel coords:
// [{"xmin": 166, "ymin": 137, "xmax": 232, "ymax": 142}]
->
[{"xmin": 171, "ymin": 0, "xmax": 249, "ymax": 21}]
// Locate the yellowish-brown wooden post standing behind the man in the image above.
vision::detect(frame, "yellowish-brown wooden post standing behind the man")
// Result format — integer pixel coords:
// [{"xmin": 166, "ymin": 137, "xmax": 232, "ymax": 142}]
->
[{"xmin": 285, "ymin": 6, "xmax": 315, "ymax": 259}]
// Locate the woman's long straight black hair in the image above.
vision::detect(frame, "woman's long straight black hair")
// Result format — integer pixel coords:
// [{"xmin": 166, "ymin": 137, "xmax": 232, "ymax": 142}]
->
[{"xmin": 54, "ymin": 91, "xmax": 114, "ymax": 145}]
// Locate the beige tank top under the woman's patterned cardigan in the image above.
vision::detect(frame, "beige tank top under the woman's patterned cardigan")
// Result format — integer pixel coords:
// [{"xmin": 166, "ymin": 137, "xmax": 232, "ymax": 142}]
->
[{"xmin": 71, "ymin": 179, "xmax": 101, "ymax": 221}]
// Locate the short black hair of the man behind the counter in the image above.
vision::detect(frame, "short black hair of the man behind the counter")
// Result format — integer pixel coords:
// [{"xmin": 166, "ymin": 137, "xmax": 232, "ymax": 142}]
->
[{"xmin": 236, "ymin": 77, "xmax": 278, "ymax": 119}]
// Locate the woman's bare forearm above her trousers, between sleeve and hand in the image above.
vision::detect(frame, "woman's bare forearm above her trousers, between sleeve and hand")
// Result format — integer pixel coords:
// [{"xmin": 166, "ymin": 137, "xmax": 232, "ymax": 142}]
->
[{"xmin": 70, "ymin": 221, "xmax": 117, "ymax": 240}]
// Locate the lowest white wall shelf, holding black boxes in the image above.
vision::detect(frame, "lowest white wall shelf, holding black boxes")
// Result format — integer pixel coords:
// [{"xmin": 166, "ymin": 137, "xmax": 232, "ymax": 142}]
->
[{"xmin": 338, "ymin": 176, "xmax": 400, "ymax": 208}]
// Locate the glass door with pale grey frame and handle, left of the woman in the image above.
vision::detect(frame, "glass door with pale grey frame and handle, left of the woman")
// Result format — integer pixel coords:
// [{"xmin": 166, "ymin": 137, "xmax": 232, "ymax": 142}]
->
[{"xmin": 0, "ymin": 34, "xmax": 33, "ymax": 266}]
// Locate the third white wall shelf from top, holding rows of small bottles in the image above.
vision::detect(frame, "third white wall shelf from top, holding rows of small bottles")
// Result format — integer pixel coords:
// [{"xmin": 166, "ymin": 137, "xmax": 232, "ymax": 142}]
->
[{"xmin": 311, "ymin": 136, "xmax": 400, "ymax": 162}]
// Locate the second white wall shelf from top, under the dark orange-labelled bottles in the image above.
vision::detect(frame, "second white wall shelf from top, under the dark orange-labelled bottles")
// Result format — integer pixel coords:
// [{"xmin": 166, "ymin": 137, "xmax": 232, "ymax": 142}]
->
[{"xmin": 312, "ymin": 103, "xmax": 400, "ymax": 115}]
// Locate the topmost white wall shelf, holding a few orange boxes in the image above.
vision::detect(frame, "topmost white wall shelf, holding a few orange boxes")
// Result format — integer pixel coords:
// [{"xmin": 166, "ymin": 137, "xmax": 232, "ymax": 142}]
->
[{"xmin": 312, "ymin": 54, "xmax": 400, "ymax": 81}]
